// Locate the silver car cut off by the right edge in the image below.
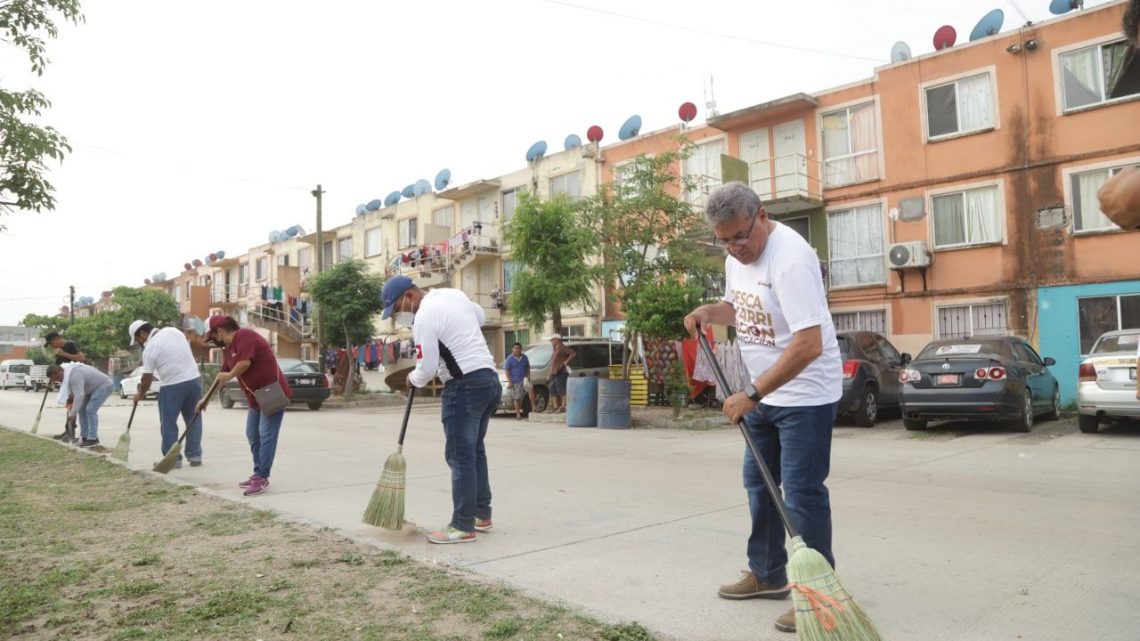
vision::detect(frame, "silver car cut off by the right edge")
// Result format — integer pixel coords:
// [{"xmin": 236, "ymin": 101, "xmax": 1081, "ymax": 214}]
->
[{"xmin": 1076, "ymin": 330, "xmax": 1140, "ymax": 433}]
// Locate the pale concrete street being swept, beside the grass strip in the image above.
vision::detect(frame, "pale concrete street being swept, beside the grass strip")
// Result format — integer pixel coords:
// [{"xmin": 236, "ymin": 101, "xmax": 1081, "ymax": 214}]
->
[{"xmin": 0, "ymin": 390, "xmax": 1140, "ymax": 641}]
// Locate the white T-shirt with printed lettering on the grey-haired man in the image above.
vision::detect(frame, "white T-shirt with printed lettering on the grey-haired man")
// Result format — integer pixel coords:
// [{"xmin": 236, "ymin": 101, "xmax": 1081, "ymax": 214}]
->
[{"xmin": 724, "ymin": 222, "xmax": 844, "ymax": 407}]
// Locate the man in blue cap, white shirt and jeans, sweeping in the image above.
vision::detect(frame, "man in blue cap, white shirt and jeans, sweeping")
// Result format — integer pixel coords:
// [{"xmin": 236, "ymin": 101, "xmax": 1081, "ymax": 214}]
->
[{"xmin": 381, "ymin": 275, "xmax": 503, "ymax": 544}]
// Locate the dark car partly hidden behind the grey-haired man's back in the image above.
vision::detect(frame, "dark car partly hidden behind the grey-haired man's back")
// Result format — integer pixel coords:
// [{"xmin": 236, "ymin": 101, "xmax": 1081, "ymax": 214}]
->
[{"xmin": 836, "ymin": 332, "xmax": 910, "ymax": 428}]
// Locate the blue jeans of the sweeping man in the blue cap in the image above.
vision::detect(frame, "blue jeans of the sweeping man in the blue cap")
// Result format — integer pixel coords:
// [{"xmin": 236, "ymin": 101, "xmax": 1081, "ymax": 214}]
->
[{"xmin": 443, "ymin": 370, "xmax": 503, "ymax": 532}]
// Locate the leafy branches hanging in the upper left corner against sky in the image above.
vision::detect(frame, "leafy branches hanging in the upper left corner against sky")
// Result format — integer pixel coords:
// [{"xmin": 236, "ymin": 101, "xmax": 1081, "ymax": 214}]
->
[{"xmin": 0, "ymin": 0, "xmax": 83, "ymax": 229}]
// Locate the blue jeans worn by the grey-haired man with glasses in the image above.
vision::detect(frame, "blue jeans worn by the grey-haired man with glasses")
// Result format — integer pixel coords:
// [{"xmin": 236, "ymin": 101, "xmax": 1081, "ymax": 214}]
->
[{"xmin": 744, "ymin": 403, "xmax": 839, "ymax": 585}]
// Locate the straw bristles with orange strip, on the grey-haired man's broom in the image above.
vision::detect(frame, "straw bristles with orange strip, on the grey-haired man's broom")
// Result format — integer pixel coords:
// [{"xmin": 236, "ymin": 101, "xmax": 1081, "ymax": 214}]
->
[{"xmin": 788, "ymin": 536, "xmax": 882, "ymax": 641}]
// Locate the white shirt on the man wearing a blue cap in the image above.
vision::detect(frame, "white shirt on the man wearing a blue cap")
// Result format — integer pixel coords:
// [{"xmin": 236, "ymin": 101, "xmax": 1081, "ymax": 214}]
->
[{"xmin": 408, "ymin": 289, "xmax": 495, "ymax": 388}]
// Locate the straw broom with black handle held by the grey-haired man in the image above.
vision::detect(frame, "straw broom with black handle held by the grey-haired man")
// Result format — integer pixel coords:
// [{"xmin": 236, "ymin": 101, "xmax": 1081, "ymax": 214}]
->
[{"xmin": 698, "ymin": 333, "xmax": 882, "ymax": 641}]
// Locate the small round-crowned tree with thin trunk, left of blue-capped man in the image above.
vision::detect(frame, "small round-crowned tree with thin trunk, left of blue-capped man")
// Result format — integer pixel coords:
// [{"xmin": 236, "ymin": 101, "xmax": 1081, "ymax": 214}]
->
[{"xmin": 309, "ymin": 255, "xmax": 384, "ymax": 400}]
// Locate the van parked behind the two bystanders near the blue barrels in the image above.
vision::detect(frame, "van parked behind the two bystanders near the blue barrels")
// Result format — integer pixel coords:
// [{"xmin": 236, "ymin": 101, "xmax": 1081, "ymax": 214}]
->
[{"xmin": 496, "ymin": 338, "xmax": 621, "ymax": 414}]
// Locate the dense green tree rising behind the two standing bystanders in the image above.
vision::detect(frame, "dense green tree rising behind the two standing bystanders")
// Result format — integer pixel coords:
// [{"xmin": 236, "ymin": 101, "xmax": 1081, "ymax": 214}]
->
[{"xmin": 503, "ymin": 193, "xmax": 599, "ymax": 333}]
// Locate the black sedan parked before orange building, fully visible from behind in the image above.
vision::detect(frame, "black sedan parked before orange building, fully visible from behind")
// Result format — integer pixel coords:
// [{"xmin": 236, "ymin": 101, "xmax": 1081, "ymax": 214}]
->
[{"xmin": 898, "ymin": 336, "xmax": 1061, "ymax": 432}]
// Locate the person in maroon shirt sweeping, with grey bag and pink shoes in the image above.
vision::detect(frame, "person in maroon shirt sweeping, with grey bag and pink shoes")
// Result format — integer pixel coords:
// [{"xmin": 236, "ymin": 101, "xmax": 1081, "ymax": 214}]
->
[{"xmin": 198, "ymin": 316, "xmax": 293, "ymax": 496}]
